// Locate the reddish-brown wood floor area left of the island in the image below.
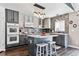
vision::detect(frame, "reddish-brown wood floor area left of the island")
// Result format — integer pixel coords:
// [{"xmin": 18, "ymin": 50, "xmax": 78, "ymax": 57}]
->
[{"xmin": 0, "ymin": 46, "xmax": 29, "ymax": 56}]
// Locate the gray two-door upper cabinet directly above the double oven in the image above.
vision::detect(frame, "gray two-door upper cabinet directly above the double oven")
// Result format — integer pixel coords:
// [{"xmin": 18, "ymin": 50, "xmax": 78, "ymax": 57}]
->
[{"xmin": 5, "ymin": 9, "xmax": 19, "ymax": 23}]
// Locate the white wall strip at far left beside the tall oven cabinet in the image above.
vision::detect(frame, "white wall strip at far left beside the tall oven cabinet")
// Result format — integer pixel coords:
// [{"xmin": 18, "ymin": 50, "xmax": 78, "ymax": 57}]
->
[{"xmin": 0, "ymin": 7, "xmax": 5, "ymax": 51}]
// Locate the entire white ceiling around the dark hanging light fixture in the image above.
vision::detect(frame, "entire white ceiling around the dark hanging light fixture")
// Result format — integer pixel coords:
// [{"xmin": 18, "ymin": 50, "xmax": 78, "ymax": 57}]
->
[{"xmin": 0, "ymin": 3, "xmax": 79, "ymax": 17}]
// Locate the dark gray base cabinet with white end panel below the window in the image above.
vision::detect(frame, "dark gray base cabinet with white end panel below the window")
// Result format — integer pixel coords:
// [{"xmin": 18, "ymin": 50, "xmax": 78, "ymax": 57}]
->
[{"xmin": 53, "ymin": 35, "xmax": 68, "ymax": 48}]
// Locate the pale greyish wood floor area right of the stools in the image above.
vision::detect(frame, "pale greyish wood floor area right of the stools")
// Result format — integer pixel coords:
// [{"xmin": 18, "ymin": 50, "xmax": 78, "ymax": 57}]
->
[{"xmin": 57, "ymin": 48, "xmax": 79, "ymax": 56}]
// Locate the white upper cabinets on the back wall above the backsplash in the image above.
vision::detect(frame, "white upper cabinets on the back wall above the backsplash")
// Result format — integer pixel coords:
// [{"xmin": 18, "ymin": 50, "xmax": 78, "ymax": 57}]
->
[{"xmin": 25, "ymin": 16, "xmax": 39, "ymax": 28}]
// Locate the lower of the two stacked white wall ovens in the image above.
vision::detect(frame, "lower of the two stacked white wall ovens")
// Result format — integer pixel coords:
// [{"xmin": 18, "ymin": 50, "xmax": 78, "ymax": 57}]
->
[{"xmin": 7, "ymin": 35, "xmax": 19, "ymax": 44}]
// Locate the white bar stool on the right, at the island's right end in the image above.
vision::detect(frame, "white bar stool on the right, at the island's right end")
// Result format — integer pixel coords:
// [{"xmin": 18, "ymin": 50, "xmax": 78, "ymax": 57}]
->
[{"xmin": 48, "ymin": 41, "xmax": 57, "ymax": 56}]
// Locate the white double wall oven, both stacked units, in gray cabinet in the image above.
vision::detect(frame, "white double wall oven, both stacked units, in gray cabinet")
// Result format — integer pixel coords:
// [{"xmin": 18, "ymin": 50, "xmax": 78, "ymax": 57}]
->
[{"xmin": 7, "ymin": 23, "xmax": 19, "ymax": 44}]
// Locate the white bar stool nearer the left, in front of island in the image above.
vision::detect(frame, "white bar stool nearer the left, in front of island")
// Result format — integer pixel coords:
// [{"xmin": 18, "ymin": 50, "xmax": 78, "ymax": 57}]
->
[{"xmin": 36, "ymin": 43, "xmax": 48, "ymax": 56}]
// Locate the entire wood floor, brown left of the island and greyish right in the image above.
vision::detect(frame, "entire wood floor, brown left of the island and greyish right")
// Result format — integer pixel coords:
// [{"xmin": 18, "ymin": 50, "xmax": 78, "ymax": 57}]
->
[{"xmin": 0, "ymin": 46, "xmax": 79, "ymax": 56}]
